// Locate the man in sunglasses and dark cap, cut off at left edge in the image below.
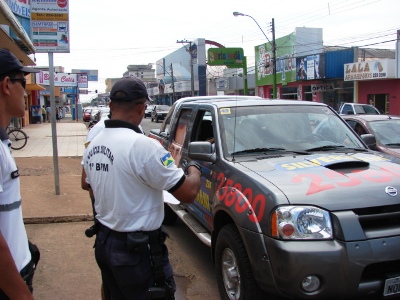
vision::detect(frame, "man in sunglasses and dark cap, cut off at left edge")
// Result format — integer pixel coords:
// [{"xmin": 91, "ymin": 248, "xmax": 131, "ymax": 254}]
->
[{"xmin": 0, "ymin": 49, "xmax": 38, "ymax": 299}]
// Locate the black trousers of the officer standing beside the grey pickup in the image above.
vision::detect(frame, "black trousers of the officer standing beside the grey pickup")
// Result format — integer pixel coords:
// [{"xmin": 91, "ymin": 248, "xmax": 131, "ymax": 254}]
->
[{"xmin": 95, "ymin": 226, "xmax": 176, "ymax": 300}]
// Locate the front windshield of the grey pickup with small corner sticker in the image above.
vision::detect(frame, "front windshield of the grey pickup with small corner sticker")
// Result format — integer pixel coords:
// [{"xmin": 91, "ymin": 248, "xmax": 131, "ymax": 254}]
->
[{"xmin": 219, "ymin": 105, "xmax": 365, "ymax": 155}]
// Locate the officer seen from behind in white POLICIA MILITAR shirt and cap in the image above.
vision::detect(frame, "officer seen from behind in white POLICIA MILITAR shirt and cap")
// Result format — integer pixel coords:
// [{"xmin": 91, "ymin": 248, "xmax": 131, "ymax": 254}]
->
[{"xmin": 83, "ymin": 77, "xmax": 201, "ymax": 300}]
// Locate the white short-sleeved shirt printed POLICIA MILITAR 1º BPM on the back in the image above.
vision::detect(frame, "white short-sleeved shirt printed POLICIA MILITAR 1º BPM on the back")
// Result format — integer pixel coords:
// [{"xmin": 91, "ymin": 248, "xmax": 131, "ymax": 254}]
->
[{"xmin": 83, "ymin": 120, "xmax": 184, "ymax": 232}]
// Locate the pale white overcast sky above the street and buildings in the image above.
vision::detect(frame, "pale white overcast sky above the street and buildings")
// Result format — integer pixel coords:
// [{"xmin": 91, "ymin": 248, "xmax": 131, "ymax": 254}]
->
[{"xmin": 29, "ymin": 0, "xmax": 400, "ymax": 102}]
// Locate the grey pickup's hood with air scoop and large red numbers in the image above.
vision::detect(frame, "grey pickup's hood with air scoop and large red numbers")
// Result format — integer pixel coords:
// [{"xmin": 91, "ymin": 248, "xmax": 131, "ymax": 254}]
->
[{"xmin": 240, "ymin": 152, "xmax": 400, "ymax": 211}]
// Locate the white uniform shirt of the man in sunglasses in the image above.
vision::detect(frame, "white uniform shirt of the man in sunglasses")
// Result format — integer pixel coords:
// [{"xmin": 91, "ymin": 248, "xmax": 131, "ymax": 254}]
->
[{"xmin": 0, "ymin": 132, "xmax": 31, "ymax": 271}]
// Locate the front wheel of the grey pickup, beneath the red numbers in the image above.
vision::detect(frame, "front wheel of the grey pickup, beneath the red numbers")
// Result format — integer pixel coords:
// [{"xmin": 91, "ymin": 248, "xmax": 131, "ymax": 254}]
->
[{"xmin": 215, "ymin": 224, "xmax": 266, "ymax": 300}]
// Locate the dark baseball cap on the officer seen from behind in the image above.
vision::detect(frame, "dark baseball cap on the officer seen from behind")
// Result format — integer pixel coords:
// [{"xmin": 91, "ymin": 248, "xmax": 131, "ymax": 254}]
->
[{"xmin": 110, "ymin": 76, "xmax": 152, "ymax": 102}]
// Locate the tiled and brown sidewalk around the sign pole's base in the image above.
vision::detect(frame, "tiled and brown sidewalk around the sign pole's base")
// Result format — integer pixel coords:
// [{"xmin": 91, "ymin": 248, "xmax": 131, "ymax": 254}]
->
[{"xmin": 16, "ymin": 115, "xmax": 93, "ymax": 224}]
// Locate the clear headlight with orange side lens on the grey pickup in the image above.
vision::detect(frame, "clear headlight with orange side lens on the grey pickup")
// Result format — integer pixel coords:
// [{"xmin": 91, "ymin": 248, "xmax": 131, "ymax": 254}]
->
[{"xmin": 271, "ymin": 206, "xmax": 332, "ymax": 240}]
